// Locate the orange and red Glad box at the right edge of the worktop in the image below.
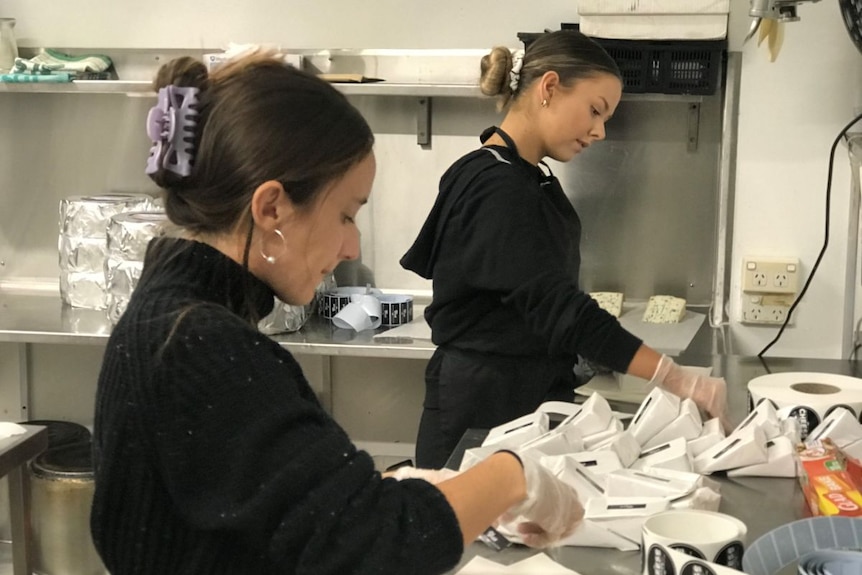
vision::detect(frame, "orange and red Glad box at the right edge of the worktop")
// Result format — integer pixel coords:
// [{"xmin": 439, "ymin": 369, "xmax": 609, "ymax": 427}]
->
[{"xmin": 796, "ymin": 439, "xmax": 862, "ymax": 517}]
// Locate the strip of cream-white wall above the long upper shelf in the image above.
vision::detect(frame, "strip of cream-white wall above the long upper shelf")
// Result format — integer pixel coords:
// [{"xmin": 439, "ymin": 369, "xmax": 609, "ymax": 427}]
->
[{"xmin": 5, "ymin": 0, "xmax": 577, "ymax": 48}]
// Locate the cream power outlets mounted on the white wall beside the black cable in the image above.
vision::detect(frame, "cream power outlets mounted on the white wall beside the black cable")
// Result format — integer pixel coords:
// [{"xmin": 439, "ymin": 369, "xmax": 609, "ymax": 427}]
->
[{"xmin": 741, "ymin": 257, "xmax": 799, "ymax": 325}]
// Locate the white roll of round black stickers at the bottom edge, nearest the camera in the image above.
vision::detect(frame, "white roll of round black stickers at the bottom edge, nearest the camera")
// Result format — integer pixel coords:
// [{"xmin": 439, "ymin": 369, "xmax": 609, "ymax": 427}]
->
[{"xmin": 642, "ymin": 509, "xmax": 748, "ymax": 575}]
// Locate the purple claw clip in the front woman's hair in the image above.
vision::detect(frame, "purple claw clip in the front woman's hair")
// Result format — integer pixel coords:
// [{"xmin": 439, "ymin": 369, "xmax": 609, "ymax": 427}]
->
[{"xmin": 146, "ymin": 85, "xmax": 200, "ymax": 177}]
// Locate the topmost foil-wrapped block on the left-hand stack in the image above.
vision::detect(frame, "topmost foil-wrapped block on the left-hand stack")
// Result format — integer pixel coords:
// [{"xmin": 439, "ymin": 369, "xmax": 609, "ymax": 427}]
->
[{"xmin": 60, "ymin": 193, "xmax": 154, "ymax": 238}]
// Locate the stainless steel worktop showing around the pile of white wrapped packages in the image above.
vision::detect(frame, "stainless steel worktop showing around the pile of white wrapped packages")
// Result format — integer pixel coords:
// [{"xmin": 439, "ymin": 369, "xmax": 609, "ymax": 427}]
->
[{"xmin": 449, "ymin": 355, "xmax": 862, "ymax": 575}]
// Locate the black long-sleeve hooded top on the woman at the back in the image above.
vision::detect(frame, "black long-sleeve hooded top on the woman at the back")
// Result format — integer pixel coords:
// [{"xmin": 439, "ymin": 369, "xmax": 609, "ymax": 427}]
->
[{"xmin": 401, "ymin": 137, "xmax": 641, "ymax": 372}]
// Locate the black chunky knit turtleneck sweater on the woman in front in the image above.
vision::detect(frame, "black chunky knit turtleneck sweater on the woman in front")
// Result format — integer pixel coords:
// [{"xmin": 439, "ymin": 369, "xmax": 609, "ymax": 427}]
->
[{"xmin": 91, "ymin": 239, "xmax": 463, "ymax": 575}]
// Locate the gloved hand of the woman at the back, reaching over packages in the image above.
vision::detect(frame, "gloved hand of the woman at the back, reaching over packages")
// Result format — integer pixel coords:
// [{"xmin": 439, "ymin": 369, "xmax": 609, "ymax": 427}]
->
[{"xmin": 650, "ymin": 355, "xmax": 731, "ymax": 430}]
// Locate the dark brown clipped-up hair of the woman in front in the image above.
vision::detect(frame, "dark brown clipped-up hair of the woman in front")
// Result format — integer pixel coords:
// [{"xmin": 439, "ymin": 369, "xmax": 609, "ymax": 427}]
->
[{"xmin": 150, "ymin": 53, "xmax": 374, "ymax": 233}]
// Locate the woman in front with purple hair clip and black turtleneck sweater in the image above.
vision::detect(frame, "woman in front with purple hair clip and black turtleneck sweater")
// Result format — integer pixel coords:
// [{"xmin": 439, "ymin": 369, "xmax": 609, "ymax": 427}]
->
[{"xmin": 91, "ymin": 51, "xmax": 583, "ymax": 575}]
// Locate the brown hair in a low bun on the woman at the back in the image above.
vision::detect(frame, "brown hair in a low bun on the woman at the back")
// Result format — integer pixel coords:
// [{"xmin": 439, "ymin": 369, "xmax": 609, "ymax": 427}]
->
[{"xmin": 479, "ymin": 30, "xmax": 622, "ymax": 109}]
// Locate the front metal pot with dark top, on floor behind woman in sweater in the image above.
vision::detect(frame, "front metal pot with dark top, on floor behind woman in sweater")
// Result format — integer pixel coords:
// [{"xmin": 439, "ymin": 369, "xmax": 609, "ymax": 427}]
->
[{"xmin": 30, "ymin": 441, "xmax": 107, "ymax": 575}]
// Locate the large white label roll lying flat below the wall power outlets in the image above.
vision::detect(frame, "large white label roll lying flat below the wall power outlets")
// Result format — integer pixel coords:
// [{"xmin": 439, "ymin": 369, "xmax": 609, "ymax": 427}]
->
[{"xmin": 748, "ymin": 372, "xmax": 862, "ymax": 439}]
